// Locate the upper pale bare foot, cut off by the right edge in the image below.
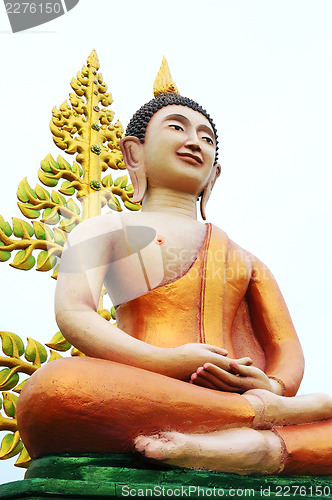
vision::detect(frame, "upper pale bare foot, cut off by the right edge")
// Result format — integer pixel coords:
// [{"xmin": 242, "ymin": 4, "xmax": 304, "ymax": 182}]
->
[{"xmin": 243, "ymin": 389, "xmax": 332, "ymax": 429}]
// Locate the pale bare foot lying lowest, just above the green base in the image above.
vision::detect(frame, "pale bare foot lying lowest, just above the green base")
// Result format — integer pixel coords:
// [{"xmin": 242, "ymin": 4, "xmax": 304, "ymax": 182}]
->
[{"xmin": 134, "ymin": 427, "xmax": 283, "ymax": 474}]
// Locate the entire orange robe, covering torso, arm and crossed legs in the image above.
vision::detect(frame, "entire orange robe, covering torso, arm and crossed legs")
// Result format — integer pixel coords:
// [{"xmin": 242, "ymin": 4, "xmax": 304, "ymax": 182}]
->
[{"xmin": 17, "ymin": 225, "xmax": 332, "ymax": 474}]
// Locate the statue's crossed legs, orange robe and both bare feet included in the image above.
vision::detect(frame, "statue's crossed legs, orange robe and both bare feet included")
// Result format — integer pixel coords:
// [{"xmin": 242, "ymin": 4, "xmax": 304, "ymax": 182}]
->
[{"xmin": 17, "ymin": 358, "xmax": 332, "ymax": 474}]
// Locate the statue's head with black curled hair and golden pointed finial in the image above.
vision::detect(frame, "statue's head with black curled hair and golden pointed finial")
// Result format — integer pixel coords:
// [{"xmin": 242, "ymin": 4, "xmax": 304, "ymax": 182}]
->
[{"xmin": 120, "ymin": 58, "xmax": 220, "ymax": 219}]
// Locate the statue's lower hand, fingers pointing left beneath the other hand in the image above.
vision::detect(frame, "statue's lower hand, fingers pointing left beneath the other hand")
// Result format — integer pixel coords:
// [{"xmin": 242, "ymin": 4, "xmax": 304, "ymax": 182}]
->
[{"xmin": 190, "ymin": 360, "xmax": 274, "ymax": 394}]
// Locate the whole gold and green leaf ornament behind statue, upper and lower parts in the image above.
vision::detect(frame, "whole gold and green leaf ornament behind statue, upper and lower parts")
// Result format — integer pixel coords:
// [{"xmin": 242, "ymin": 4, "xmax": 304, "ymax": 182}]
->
[{"xmin": 0, "ymin": 50, "xmax": 141, "ymax": 467}]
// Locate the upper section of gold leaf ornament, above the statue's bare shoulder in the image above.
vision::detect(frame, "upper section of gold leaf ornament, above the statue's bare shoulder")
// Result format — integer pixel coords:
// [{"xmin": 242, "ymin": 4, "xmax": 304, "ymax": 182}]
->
[{"xmin": 0, "ymin": 50, "xmax": 141, "ymax": 278}]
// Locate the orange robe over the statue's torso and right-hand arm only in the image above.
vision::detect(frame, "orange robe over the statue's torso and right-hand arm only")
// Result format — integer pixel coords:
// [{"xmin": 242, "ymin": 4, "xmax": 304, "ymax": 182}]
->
[{"xmin": 117, "ymin": 224, "xmax": 304, "ymax": 396}]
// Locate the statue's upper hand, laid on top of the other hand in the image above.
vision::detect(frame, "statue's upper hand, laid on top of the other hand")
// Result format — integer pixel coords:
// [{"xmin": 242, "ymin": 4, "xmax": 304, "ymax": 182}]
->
[{"xmin": 166, "ymin": 343, "xmax": 252, "ymax": 382}]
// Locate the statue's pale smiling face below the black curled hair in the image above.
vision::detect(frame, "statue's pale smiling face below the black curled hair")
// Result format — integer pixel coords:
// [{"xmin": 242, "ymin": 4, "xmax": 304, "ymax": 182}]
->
[{"xmin": 143, "ymin": 105, "xmax": 216, "ymax": 196}]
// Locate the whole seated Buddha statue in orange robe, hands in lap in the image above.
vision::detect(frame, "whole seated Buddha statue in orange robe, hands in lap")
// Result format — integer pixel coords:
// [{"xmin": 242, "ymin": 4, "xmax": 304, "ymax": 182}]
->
[{"xmin": 17, "ymin": 59, "xmax": 332, "ymax": 475}]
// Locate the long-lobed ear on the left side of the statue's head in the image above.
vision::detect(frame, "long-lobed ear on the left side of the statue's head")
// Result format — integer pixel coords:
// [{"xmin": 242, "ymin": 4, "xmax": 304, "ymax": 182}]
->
[{"xmin": 120, "ymin": 136, "xmax": 147, "ymax": 203}]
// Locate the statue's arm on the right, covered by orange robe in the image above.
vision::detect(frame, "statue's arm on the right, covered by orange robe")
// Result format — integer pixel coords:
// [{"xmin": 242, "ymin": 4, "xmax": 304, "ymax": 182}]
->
[{"xmin": 247, "ymin": 258, "xmax": 304, "ymax": 396}]
